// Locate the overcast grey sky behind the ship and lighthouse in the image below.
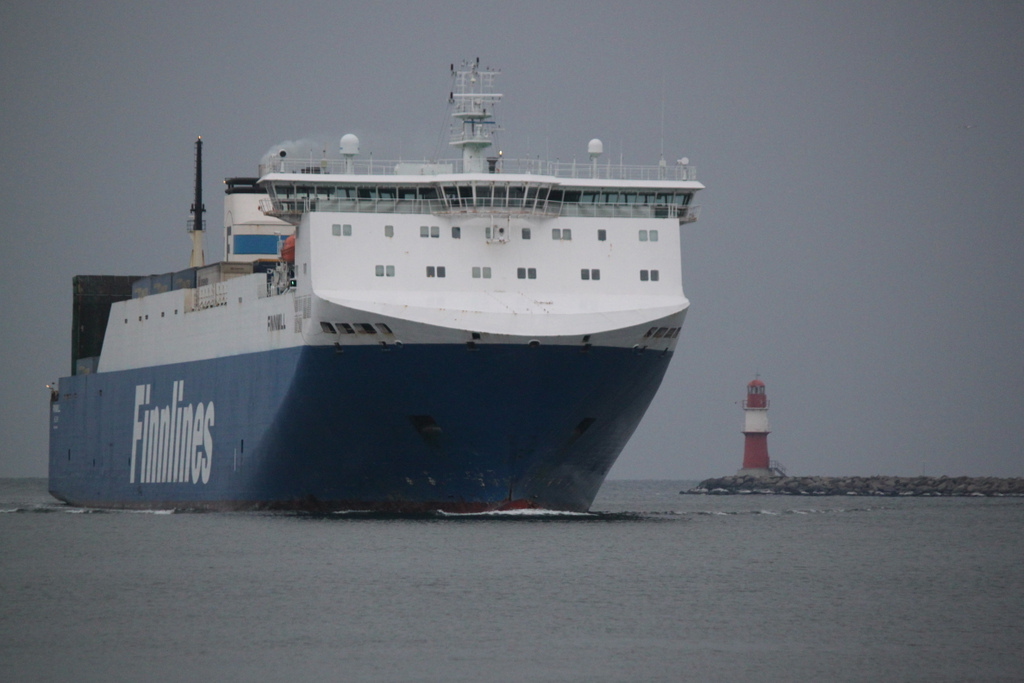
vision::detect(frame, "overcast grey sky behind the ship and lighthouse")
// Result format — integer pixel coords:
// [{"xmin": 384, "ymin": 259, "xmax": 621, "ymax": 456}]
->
[{"xmin": 0, "ymin": 0, "xmax": 1024, "ymax": 479}]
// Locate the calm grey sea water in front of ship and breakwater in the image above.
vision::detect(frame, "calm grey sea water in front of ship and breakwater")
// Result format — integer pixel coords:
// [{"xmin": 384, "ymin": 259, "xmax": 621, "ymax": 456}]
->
[{"xmin": 0, "ymin": 479, "xmax": 1024, "ymax": 681}]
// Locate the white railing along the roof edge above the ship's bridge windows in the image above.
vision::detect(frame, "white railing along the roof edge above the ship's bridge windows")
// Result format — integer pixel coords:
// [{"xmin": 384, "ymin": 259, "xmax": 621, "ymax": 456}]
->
[{"xmin": 259, "ymin": 158, "xmax": 697, "ymax": 180}]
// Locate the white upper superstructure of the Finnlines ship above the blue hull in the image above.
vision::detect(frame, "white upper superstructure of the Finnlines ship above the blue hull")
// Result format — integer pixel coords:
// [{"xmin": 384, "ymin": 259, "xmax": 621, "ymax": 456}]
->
[{"xmin": 99, "ymin": 63, "xmax": 703, "ymax": 371}]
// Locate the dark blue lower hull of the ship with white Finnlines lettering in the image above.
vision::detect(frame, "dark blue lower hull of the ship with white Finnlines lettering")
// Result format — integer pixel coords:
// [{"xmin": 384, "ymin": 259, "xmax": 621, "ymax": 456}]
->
[{"xmin": 49, "ymin": 344, "xmax": 672, "ymax": 512}]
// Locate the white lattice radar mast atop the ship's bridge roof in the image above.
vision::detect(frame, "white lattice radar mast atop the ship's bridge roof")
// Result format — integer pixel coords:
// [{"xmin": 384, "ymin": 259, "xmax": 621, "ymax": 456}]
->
[{"xmin": 450, "ymin": 57, "xmax": 502, "ymax": 173}]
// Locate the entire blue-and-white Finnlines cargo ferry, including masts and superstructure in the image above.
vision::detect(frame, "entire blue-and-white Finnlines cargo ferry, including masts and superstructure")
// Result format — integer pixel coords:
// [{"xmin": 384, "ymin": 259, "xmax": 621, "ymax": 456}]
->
[{"xmin": 49, "ymin": 62, "xmax": 702, "ymax": 512}]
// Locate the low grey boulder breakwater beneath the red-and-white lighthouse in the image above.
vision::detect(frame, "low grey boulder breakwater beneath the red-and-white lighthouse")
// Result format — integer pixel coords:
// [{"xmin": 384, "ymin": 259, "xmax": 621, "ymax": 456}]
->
[{"xmin": 679, "ymin": 475, "xmax": 1024, "ymax": 497}]
